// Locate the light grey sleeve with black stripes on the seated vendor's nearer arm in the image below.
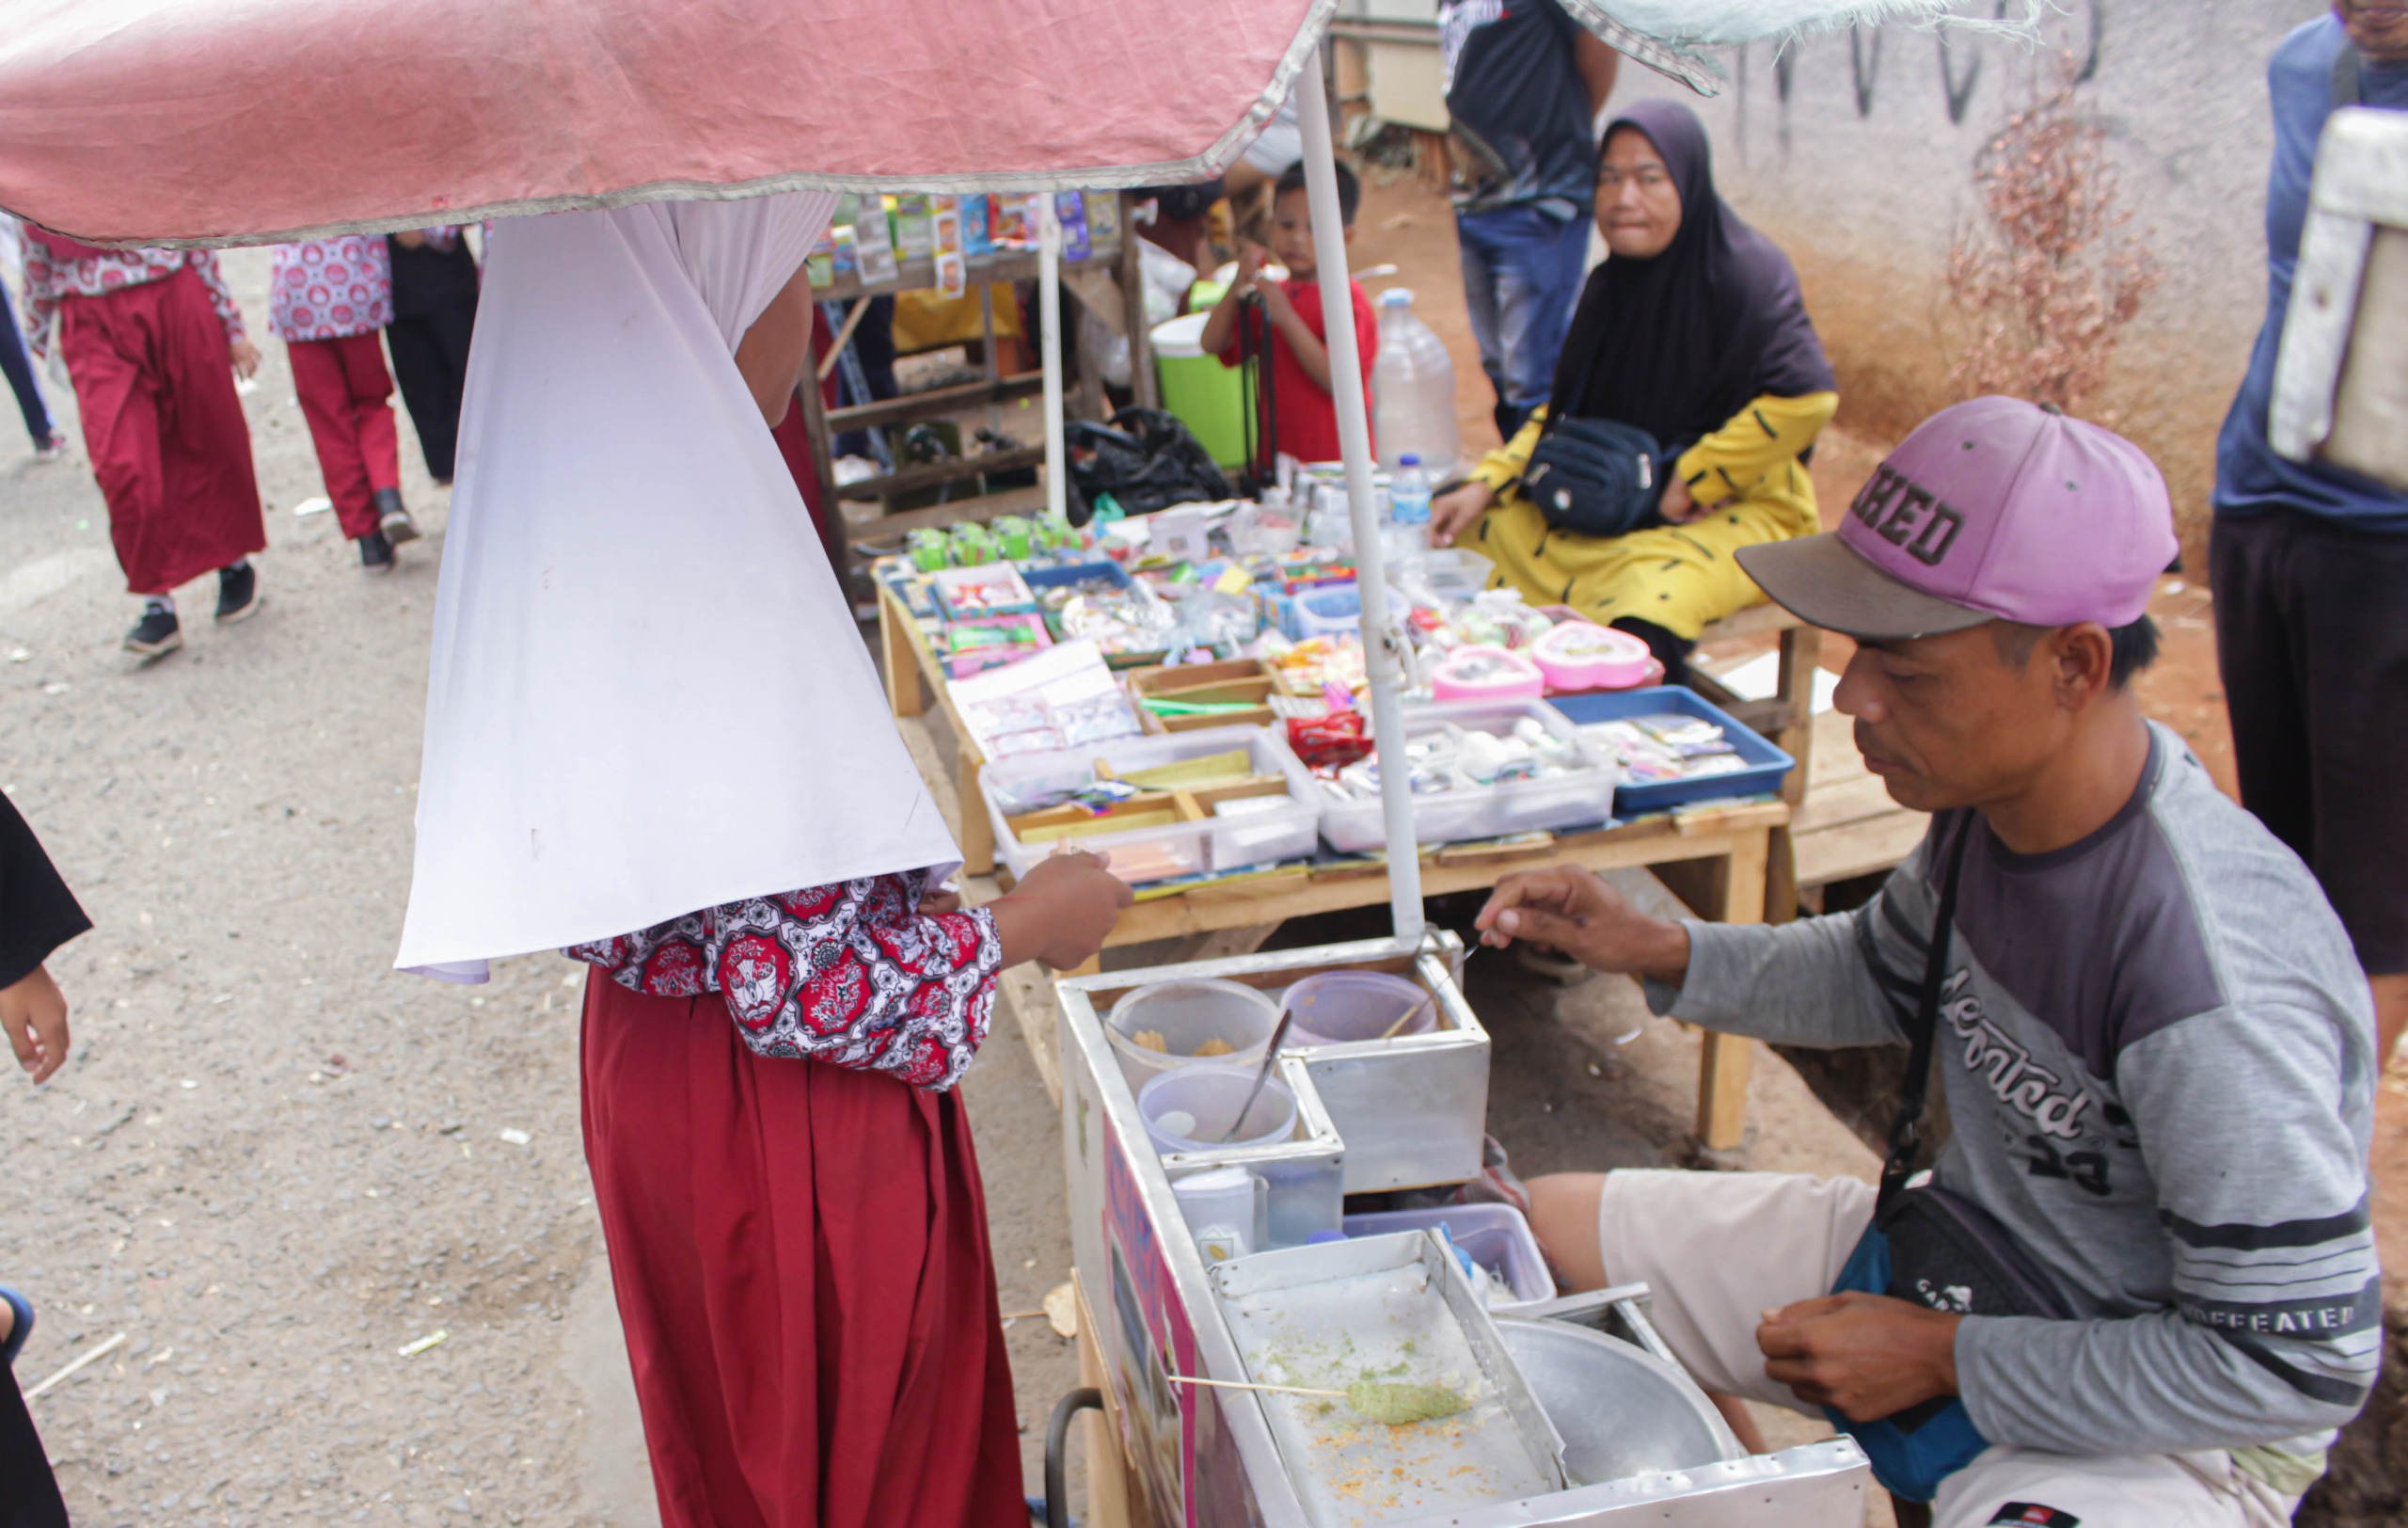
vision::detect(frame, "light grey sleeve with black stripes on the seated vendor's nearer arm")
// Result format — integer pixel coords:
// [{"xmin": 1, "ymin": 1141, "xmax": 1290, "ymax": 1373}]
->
[{"xmin": 1956, "ymin": 1005, "xmax": 2384, "ymax": 1454}]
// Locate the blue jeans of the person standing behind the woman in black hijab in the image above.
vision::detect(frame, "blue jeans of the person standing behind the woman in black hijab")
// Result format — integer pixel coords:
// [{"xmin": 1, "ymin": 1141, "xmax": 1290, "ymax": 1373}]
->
[{"xmin": 1454, "ymin": 207, "xmax": 1590, "ymax": 438}]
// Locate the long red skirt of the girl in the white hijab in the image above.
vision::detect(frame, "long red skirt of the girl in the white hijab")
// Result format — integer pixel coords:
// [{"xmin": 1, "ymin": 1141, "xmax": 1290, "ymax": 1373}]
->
[{"xmin": 583, "ymin": 976, "xmax": 1028, "ymax": 1528}]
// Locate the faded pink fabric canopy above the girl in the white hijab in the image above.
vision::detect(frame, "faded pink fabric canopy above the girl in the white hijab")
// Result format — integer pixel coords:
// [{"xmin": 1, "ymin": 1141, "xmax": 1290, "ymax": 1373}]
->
[{"xmin": 0, "ymin": 0, "xmax": 1334, "ymax": 244}]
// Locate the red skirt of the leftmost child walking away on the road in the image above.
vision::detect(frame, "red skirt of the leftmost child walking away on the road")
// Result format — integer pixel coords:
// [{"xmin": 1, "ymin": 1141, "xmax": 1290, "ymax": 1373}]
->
[{"xmin": 57, "ymin": 270, "xmax": 267, "ymax": 596}]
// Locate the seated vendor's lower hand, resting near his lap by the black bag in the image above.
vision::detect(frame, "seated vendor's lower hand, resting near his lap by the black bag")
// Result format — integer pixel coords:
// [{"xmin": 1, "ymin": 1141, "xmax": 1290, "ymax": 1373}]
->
[{"xmin": 1755, "ymin": 1289, "xmax": 1962, "ymax": 1422}]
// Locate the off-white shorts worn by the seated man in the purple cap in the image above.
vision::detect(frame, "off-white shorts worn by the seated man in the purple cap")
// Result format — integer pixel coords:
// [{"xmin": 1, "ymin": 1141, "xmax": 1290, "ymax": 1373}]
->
[{"xmin": 1596, "ymin": 1169, "xmax": 2297, "ymax": 1528}]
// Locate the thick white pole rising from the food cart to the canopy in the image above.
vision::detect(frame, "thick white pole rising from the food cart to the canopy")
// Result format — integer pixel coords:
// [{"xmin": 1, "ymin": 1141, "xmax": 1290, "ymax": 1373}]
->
[{"xmin": 1295, "ymin": 53, "xmax": 1420, "ymax": 940}]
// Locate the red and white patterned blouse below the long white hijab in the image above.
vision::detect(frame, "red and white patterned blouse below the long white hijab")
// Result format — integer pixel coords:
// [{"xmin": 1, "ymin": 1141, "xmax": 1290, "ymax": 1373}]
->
[{"xmin": 563, "ymin": 872, "xmax": 1005, "ymax": 1091}]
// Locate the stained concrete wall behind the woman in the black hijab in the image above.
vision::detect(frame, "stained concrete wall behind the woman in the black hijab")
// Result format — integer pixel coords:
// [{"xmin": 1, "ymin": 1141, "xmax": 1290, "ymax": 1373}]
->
[{"xmin": 1616, "ymin": 0, "xmax": 2326, "ymax": 533}]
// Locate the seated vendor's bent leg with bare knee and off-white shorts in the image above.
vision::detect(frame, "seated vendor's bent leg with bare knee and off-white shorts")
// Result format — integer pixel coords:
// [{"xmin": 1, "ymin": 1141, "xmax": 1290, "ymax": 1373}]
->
[{"xmin": 1529, "ymin": 1169, "xmax": 1874, "ymax": 1417}]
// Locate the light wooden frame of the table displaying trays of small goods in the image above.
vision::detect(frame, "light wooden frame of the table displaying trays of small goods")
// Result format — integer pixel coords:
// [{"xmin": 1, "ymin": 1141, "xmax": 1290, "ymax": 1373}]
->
[{"xmin": 879, "ymin": 583, "xmax": 1789, "ymax": 1150}]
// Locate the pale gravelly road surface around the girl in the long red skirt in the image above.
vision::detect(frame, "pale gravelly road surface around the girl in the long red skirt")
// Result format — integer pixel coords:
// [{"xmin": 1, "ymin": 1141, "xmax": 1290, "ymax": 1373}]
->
[{"xmin": 0, "ymin": 250, "xmax": 1074, "ymax": 1525}]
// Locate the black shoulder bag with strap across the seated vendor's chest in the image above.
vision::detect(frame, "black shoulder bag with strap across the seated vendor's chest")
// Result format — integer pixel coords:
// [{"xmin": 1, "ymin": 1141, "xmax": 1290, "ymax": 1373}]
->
[{"xmin": 1825, "ymin": 812, "xmax": 2071, "ymax": 1502}]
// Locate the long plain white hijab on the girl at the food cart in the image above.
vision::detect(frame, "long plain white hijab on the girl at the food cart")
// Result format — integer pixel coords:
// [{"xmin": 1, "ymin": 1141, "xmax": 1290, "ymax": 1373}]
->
[{"xmin": 395, "ymin": 193, "xmax": 960, "ymax": 981}]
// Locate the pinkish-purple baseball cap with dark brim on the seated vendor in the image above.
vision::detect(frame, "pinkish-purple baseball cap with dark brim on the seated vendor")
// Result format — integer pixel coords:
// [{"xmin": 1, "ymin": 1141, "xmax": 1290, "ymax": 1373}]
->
[{"xmin": 1738, "ymin": 398, "xmax": 2177, "ymax": 641}]
